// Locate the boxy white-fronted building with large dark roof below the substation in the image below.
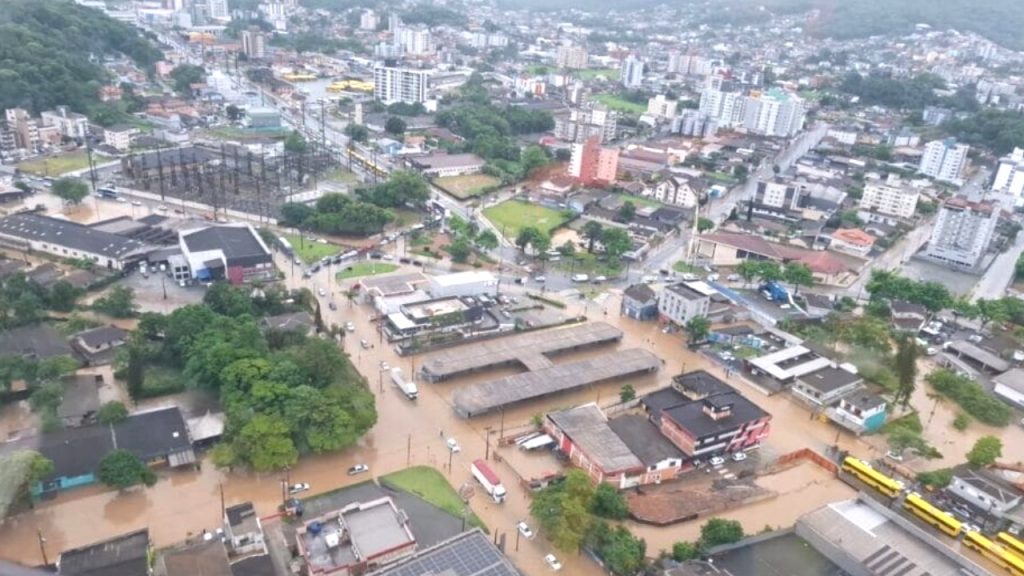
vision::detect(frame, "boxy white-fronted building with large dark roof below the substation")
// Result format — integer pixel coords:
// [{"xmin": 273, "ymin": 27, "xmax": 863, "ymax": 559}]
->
[{"xmin": 178, "ymin": 224, "xmax": 275, "ymax": 284}]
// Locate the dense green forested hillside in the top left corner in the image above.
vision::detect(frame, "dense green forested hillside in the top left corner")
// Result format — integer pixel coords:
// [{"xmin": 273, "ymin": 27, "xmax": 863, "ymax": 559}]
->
[{"xmin": 0, "ymin": 0, "xmax": 162, "ymax": 113}]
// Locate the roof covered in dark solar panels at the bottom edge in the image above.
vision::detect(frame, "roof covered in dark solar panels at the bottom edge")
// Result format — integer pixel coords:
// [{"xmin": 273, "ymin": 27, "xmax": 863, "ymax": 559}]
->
[{"xmin": 372, "ymin": 528, "xmax": 520, "ymax": 576}]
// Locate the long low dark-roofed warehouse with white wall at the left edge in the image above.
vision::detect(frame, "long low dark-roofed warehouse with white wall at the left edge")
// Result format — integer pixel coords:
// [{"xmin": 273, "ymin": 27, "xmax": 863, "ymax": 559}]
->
[{"xmin": 0, "ymin": 213, "xmax": 151, "ymax": 270}]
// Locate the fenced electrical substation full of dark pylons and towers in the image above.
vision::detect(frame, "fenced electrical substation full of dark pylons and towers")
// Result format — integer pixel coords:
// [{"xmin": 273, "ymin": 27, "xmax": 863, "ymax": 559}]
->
[{"xmin": 115, "ymin": 141, "xmax": 341, "ymax": 221}]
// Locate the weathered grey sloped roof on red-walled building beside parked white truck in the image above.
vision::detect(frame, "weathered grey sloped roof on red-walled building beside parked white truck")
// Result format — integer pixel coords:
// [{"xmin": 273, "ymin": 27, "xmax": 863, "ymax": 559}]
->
[{"xmin": 548, "ymin": 404, "xmax": 644, "ymax": 475}]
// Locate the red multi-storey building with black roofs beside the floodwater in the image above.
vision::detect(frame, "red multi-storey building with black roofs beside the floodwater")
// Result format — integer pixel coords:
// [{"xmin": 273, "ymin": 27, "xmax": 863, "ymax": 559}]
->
[{"xmin": 640, "ymin": 370, "xmax": 771, "ymax": 458}]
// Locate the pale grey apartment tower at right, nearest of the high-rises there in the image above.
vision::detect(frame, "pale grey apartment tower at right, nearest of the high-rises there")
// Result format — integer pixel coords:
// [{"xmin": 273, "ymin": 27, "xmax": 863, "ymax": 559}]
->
[{"xmin": 924, "ymin": 196, "xmax": 999, "ymax": 270}]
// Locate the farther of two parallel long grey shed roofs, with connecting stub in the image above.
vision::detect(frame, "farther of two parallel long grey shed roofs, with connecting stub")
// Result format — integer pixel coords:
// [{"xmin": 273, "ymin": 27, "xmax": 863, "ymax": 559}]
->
[{"xmin": 423, "ymin": 322, "xmax": 623, "ymax": 380}]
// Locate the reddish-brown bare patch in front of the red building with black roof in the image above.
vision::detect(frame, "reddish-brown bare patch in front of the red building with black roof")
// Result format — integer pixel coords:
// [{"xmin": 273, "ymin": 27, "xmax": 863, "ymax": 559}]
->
[{"xmin": 626, "ymin": 472, "xmax": 776, "ymax": 526}]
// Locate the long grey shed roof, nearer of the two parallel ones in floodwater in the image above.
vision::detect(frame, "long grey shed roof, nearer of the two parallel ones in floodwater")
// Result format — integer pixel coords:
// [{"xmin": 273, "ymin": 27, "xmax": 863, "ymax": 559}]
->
[{"xmin": 452, "ymin": 348, "xmax": 662, "ymax": 417}]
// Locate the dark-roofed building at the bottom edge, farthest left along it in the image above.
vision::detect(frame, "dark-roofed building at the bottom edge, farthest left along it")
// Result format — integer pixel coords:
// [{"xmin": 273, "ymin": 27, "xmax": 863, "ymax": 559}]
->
[{"xmin": 56, "ymin": 529, "xmax": 150, "ymax": 576}]
